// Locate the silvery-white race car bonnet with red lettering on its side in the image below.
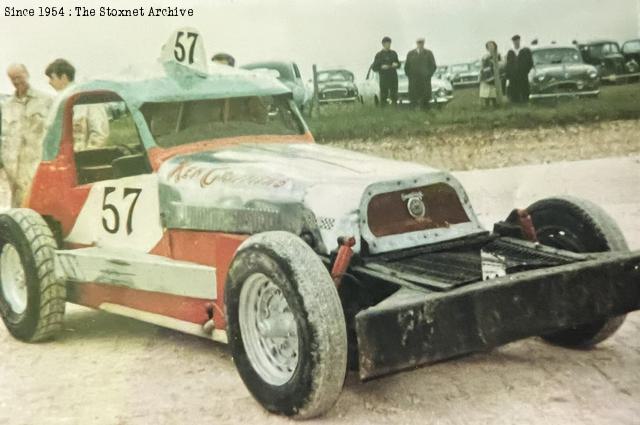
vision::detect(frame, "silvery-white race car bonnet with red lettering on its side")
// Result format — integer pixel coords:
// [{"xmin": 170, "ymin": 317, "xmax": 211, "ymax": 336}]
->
[{"xmin": 158, "ymin": 143, "xmax": 480, "ymax": 252}]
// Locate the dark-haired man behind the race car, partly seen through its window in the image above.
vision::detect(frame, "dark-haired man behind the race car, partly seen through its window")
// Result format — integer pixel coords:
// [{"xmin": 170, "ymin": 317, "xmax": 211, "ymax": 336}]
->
[{"xmin": 44, "ymin": 59, "xmax": 109, "ymax": 150}]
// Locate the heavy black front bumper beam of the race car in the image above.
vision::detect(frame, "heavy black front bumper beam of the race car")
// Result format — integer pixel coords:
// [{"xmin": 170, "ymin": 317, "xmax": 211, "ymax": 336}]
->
[{"xmin": 356, "ymin": 251, "xmax": 640, "ymax": 379}]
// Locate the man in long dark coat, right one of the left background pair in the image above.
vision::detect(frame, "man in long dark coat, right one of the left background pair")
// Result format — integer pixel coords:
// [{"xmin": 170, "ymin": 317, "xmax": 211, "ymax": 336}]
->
[{"xmin": 404, "ymin": 38, "xmax": 436, "ymax": 109}]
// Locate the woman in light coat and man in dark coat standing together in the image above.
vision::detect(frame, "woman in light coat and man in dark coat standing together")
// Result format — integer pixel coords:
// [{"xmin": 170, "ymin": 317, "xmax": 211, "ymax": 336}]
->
[{"xmin": 480, "ymin": 35, "xmax": 533, "ymax": 106}]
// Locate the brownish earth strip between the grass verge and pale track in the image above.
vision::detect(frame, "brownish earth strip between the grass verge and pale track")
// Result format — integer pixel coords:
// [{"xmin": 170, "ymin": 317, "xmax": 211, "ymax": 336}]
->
[{"xmin": 331, "ymin": 120, "xmax": 640, "ymax": 170}]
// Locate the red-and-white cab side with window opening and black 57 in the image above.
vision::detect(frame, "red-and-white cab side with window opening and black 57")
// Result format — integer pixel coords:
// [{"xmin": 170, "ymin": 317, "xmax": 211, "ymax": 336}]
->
[{"xmin": 32, "ymin": 92, "xmax": 163, "ymax": 252}]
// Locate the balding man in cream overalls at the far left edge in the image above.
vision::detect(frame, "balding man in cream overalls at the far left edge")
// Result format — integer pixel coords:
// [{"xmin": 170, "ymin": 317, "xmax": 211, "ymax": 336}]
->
[{"xmin": 0, "ymin": 64, "xmax": 52, "ymax": 207}]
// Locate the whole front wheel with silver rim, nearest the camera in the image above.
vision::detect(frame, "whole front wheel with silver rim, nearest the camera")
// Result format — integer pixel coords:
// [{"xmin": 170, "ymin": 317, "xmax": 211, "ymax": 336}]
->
[{"xmin": 225, "ymin": 232, "xmax": 347, "ymax": 419}]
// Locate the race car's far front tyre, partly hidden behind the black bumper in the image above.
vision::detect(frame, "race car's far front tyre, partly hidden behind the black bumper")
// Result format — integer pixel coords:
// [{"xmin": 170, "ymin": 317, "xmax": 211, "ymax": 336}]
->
[{"xmin": 527, "ymin": 197, "xmax": 629, "ymax": 348}]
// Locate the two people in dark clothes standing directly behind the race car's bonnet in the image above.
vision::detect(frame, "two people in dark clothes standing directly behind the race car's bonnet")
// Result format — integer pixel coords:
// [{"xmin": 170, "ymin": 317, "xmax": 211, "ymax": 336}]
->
[{"xmin": 372, "ymin": 37, "xmax": 436, "ymax": 109}]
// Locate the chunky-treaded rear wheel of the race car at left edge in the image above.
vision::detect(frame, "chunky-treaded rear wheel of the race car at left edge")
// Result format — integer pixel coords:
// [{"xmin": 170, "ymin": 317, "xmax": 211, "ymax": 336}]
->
[{"xmin": 0, "ymin": 208, "xmax": 66, "ymax": 342}]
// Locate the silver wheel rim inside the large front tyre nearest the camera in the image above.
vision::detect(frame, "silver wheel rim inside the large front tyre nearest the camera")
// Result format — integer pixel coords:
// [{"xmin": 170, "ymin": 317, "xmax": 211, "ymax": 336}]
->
[{"xmin": 238, "ymin": 273, "xmax": 299, "ymax": 386}]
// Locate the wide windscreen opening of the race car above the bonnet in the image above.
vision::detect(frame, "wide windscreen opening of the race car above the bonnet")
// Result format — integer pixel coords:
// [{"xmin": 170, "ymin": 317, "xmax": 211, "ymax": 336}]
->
[{"xmin": 140, "ymin": 95, "xmax": 303, "ymax": 147}]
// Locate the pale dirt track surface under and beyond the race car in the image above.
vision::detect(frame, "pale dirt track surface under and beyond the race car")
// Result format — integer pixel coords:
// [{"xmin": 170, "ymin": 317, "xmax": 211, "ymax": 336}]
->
[{"xmin": 0, "ymin": 157, "xmax": 640, "ymax": 425}]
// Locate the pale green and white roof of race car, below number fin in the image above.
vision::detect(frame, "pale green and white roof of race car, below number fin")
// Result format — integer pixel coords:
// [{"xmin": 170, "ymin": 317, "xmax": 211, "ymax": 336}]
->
[{"xmin": 67, "ymin": 65, "xmax": 291, "ymax": 107}]
